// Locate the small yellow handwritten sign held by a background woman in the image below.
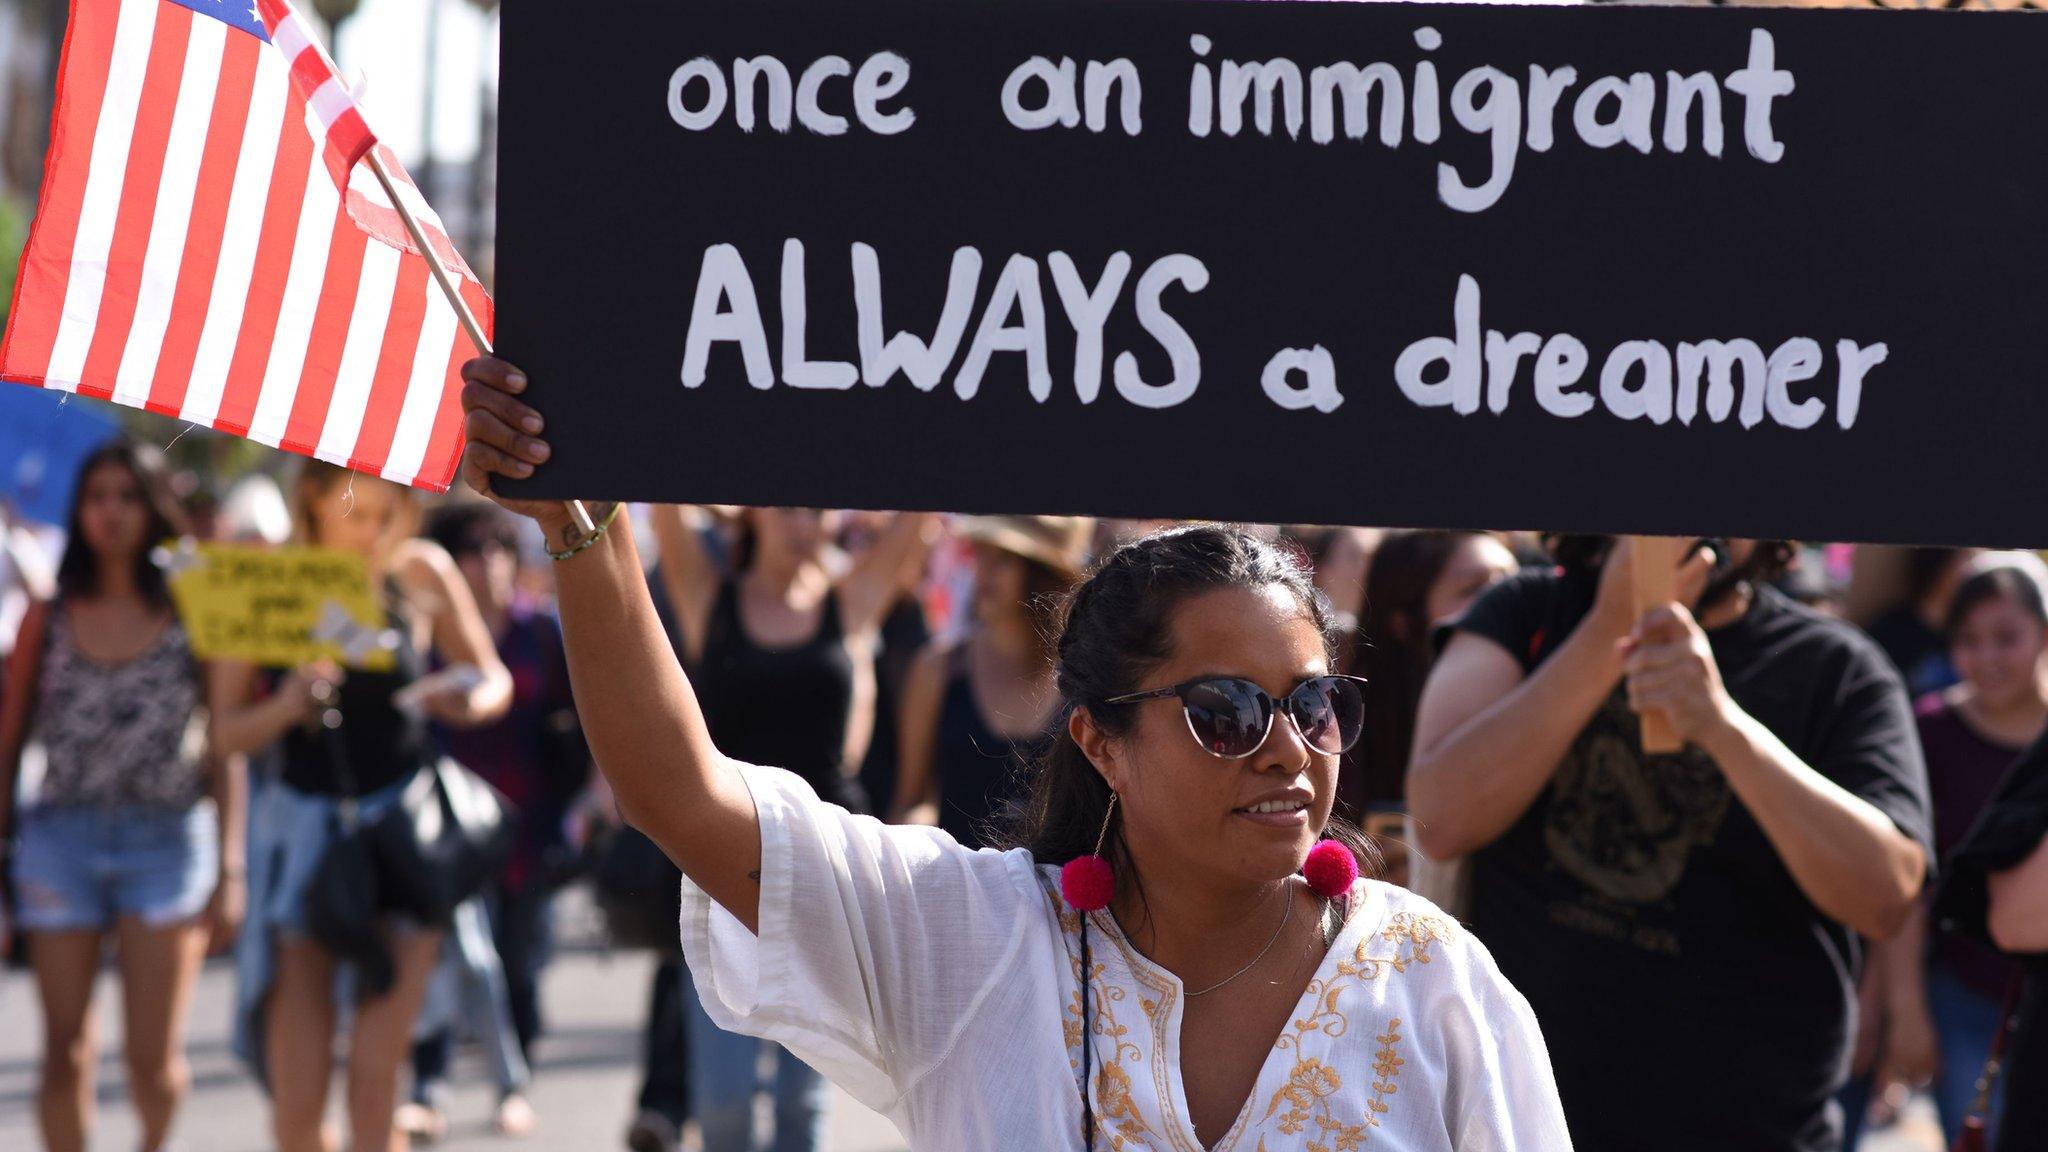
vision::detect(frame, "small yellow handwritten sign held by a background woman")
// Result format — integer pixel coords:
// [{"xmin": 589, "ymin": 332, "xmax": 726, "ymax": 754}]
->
[{"xmin": 166, "ymin": 541, "xmax": 395, "ymax": 672}]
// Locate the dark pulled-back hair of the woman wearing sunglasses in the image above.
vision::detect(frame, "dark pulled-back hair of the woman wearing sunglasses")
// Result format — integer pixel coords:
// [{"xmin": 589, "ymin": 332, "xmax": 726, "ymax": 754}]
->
[{"xmin": 1001, "ymin": 525, "xmax": 1378, "ymax": 875}]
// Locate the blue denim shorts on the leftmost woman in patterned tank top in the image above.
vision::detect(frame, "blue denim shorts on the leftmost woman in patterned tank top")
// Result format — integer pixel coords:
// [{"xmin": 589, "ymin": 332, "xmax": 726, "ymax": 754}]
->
[{"xmin": 10, "ymin": 801, "xmax": 221, "ymax": 933}]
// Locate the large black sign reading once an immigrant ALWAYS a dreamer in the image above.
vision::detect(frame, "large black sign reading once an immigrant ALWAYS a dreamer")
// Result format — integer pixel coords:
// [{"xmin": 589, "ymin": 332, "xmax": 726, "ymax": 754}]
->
[{"xmin": 498, "ymin": 0, "xmax": 2048, "ymax": 545}]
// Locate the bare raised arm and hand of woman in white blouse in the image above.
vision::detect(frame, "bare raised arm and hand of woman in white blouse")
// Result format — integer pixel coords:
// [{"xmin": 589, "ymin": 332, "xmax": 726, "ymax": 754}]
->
[{"xmin": 463, "ymin": 359, "xmax": 762, "ymax": 931}]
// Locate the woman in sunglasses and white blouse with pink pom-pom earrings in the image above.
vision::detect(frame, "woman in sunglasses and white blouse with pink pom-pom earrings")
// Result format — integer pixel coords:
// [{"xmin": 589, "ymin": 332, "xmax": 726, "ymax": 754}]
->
[{"xmin": 465, "ymin": 361, "xmax": 1571, "ymax": 1152}]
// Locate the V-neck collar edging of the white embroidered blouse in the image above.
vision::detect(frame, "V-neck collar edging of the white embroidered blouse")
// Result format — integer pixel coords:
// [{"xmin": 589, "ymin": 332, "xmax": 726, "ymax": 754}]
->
[{"xmin": 1081, "ymin": 881, "xmax": 1386, "ymax": 1152}]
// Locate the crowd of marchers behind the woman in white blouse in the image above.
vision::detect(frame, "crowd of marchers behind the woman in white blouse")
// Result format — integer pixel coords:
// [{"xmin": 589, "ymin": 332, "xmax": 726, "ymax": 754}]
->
[{"xmin": 0, "ymin": 432, "xmax": 2048, "ymax": 1152}]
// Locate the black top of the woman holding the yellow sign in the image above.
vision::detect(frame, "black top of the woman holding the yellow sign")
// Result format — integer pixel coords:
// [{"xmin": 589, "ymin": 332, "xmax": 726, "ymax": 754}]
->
[{"xmin": 283, "ymin": 586, "xmax": 434, "ymax": 795}]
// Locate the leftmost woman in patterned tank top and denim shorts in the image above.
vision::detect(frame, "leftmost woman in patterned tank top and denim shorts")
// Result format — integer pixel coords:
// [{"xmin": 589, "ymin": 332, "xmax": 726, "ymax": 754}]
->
[{"xmin": 0, "ymin": 439, "xmax": 244, "ymax": 1152}]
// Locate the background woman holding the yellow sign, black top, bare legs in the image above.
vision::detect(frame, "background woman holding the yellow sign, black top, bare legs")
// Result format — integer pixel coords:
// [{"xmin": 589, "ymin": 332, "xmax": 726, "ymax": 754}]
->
[{"xmin": 211, "ymin": 461, "xmax": 512, "ymax": 1152}]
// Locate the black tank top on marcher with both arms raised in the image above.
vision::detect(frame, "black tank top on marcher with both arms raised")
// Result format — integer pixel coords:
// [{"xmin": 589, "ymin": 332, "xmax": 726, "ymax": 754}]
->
[{"xmin": 696, "ymin": 580, "xmax": 866, "ymax": 812}]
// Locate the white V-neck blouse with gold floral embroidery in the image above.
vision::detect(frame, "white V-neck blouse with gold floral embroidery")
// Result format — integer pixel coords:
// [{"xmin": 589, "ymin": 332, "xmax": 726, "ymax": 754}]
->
[{"xmin": 682, "ymin": 767, "xmax": 1571, "ymax": 1152}]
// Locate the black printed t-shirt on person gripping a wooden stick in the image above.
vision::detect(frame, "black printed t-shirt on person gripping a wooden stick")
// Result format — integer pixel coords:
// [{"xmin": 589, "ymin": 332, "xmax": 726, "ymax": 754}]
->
[{"xmin": 1454, "ymin": 572, "xmax": 1929, "ymax": 1152}]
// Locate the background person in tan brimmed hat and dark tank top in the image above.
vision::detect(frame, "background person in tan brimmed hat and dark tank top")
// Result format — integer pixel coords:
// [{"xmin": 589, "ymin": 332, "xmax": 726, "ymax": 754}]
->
[{"xmin": 895, "ymin": 517, "xmax": 1094, "ymax": 849}]
